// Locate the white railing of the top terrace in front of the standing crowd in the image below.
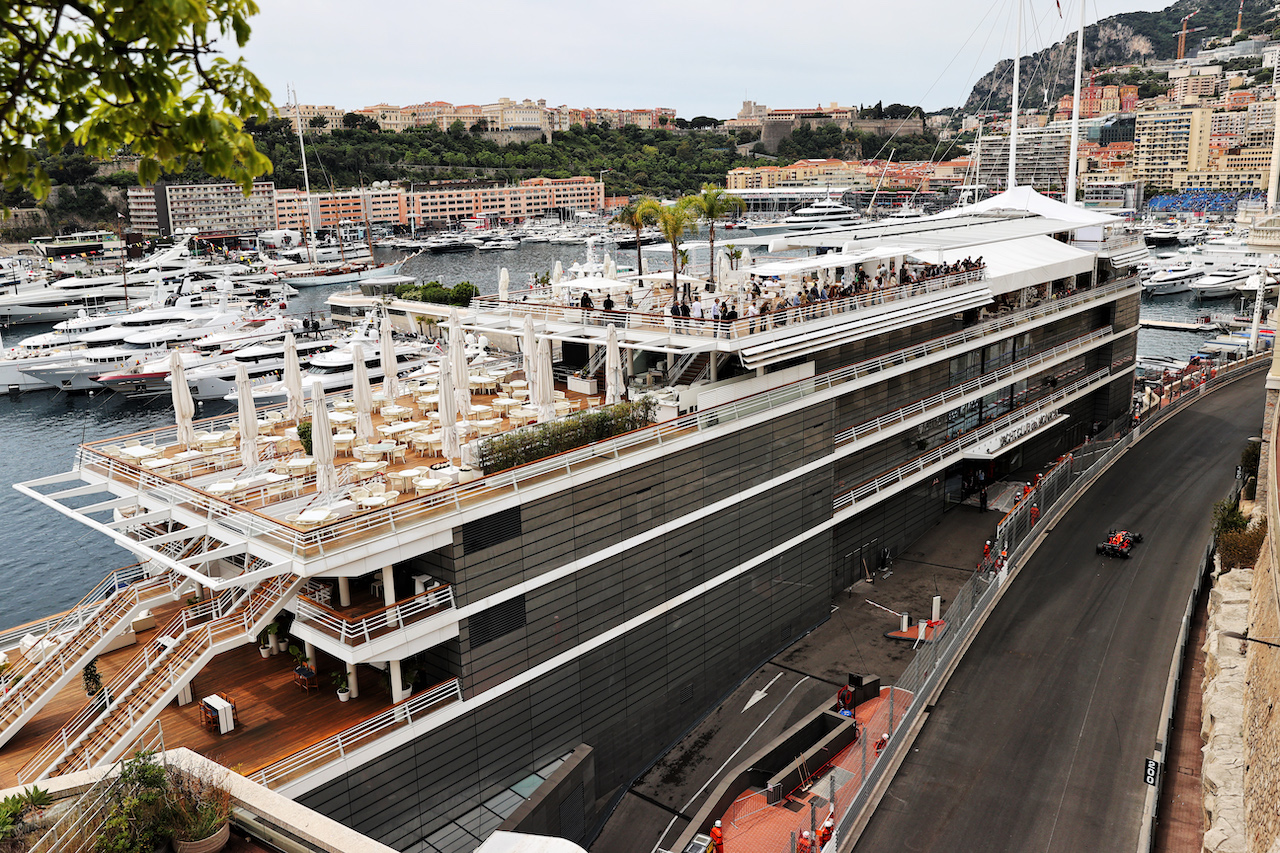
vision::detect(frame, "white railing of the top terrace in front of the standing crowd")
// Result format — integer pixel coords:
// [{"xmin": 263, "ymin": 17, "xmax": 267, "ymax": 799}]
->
[{"xmin": 471, "ymin": 268, "xmax": 987, "ymax": 339}]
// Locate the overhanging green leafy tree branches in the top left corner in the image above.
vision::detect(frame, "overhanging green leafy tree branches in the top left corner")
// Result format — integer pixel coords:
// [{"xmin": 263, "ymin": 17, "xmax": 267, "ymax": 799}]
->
[{"xmin": 0, "ymin": 0, "xmax": 271, "ymax": 199}]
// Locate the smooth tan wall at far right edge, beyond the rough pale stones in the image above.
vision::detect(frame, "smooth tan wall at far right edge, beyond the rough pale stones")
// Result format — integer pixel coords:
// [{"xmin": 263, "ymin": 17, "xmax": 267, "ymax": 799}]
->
[{"xmin": 1235, "ymin": 532, "xmax": 1280, "ymax": 853}]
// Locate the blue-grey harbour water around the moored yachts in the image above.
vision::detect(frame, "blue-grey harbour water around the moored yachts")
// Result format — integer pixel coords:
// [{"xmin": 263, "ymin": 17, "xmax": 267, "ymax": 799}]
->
[{"xmin": 0, "ymin": 242, "xmax": 1233, "ymax": 628}]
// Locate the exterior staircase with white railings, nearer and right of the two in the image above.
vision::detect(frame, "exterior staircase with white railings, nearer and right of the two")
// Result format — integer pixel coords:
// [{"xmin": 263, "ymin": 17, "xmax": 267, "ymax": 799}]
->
[{"xmin": 18, "ymin": 574, "xmax": 303, "ymax": 784}]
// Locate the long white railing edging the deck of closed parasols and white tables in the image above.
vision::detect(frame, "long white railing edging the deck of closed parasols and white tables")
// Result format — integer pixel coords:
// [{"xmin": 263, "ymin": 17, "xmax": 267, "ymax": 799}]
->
[{"xmin": 67, "ymin": 277, "xmax": 1139, "ymax": 553}]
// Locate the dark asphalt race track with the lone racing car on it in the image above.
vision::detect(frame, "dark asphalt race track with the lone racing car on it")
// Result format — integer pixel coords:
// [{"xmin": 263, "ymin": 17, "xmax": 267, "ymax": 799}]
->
[{"xmin": 854, "ymin": 371, "xmax": 1265, "ymax": 853}]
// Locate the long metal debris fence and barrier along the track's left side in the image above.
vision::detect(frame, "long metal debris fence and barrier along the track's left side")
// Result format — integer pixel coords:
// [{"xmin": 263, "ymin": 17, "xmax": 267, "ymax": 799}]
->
[{"xmin": 829, "ymin": 352, "xmax": 1271, "ymax": 849}]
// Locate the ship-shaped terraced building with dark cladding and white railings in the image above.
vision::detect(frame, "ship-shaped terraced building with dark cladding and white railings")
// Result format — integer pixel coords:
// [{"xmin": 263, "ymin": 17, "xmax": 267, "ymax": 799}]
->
[{"xmin": 0, "ymin": 190, "xmax": 1146, "ymax": 853}]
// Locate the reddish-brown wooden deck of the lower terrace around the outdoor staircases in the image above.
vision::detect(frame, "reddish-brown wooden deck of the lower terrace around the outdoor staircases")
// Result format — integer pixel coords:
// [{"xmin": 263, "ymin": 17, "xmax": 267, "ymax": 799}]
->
[{"xmin": 0, "ymin": 603, "xmax": 392, "ymax": 788}]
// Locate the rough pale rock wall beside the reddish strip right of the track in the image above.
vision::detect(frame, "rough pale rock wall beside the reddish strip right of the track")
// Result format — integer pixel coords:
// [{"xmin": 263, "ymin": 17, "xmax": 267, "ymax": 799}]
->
[{"xmin": 1201, "ymin": 560, "xmax": 1253, "ymax": 853}]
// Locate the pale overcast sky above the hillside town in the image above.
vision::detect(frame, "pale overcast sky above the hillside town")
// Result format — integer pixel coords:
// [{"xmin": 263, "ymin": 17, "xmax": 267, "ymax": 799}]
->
[{"xmin": 235, "ymin": 0, "xmax": 1169, "ymax": 118}]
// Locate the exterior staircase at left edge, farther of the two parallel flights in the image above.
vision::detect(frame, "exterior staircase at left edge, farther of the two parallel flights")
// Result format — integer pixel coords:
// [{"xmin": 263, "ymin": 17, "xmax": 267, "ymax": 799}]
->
[{"xmin": 0, "ymin": 566, "xmax": 183, "ymax": 744}]
